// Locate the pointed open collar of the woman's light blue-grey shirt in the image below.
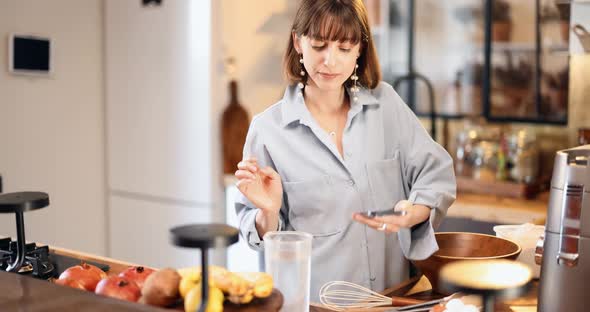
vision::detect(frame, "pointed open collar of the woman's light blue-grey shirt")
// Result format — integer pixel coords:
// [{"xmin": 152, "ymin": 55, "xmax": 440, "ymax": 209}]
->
[{"xmin": 281, "ymin": 84, "xmax": 379, "ymax": 127}]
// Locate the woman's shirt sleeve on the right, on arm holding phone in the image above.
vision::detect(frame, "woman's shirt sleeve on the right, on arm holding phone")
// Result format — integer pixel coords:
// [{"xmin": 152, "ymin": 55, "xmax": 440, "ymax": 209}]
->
[{"xmin": 396, "ymin": 93, "xmax": 457, "ymax": 260}]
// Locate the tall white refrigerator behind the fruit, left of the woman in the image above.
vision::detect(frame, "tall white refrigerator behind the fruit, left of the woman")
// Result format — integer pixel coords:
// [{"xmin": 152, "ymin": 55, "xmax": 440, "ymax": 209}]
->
[{"xmin": 105, "ymin": 0, "xmax": 223, "ymax": 267}]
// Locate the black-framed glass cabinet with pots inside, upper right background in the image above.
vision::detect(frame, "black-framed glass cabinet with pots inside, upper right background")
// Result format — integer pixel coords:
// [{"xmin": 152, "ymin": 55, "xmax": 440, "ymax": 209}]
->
[{"xmin": 482, "ymin": 0, "xmax": 569, "ymax": 125}]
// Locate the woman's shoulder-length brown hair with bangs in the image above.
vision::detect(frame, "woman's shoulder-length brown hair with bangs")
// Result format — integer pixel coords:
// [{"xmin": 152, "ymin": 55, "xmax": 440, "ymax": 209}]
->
[{"xmin": 283, "ymin": 0, "xmax": 381, "ymax": 89}]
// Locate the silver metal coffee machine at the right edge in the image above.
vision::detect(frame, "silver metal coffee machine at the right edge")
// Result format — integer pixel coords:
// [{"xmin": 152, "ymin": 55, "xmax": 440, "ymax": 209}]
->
[{"xmin": 535, "ymin": 145, "xmax": 590, "ymax": 312}]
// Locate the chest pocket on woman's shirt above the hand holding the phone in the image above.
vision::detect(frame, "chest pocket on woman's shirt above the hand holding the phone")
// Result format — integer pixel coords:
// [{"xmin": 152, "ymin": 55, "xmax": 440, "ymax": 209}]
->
[{"xmin": 366, "ymin": 155, "xmax": 407, "ymax": 210}]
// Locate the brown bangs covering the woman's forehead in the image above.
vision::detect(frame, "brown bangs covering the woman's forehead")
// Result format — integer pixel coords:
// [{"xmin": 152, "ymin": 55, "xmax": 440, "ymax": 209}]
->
[{"xmin": 304, "ymin": 5, "xmax": 363, "ymax": 44}]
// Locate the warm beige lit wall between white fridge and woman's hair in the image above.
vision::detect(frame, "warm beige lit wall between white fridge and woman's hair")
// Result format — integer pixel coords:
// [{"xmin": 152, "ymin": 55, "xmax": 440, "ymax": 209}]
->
[{"xmin": 218, "ymin": 0, "xmax": 299, "ymax": 116}]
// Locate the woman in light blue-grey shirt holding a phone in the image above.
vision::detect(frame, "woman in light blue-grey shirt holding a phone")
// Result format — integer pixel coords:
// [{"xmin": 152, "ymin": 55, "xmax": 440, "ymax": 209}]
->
[{"xmin": 235, "ymin": 0, "xmax": 456, "ymax": 301}]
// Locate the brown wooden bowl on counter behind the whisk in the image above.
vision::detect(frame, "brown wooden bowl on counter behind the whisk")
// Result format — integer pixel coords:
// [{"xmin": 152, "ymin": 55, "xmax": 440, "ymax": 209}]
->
[{"xmin": 412, "ymin": 232, "xmax": 521, "ymax": 294}]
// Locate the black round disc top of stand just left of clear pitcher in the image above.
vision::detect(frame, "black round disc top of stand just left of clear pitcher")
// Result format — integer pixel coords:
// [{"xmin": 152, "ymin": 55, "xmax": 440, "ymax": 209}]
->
[{"xmin": 170, "ymin": 223, "xmax": 239, "ymax": 249}]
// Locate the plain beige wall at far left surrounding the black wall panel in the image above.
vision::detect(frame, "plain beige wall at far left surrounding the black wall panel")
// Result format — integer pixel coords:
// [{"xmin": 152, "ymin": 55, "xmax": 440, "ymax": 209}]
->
[{"xmin": 0, "ymin": 0, "xmax": 106, "ymax": 254}]
